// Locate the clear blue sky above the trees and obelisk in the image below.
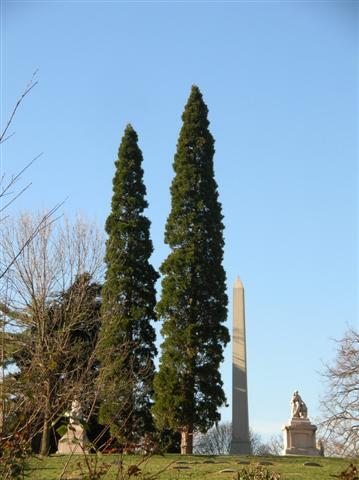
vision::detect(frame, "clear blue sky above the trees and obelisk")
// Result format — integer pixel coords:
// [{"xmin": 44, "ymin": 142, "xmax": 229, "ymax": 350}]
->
[{"xmin": 1, "ymin": 1, "xmax": 359, "ymax": 440}]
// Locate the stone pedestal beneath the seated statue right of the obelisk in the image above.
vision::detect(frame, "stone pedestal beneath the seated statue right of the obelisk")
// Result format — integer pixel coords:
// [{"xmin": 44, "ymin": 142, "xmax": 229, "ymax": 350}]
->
[{"xmin": 282, "ymin": 418, "xmax": 321, "ymax": 457}]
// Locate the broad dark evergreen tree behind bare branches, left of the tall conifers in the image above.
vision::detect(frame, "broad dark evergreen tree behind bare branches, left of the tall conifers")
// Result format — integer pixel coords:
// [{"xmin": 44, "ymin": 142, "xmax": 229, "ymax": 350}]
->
[{"xmin": 0, "ymin": 273, "xmax": 101, "ymax": 454}]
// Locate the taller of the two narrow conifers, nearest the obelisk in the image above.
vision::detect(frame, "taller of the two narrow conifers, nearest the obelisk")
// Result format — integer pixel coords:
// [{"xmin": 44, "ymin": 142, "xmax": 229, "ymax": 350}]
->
[{"xmin": 153, "ymin": 86, "xmax": 229, "ymax": 453}]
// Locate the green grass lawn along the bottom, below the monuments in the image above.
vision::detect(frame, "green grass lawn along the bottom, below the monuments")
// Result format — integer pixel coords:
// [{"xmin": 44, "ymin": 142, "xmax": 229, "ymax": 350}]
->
[{"xmin": 27, "ymin": 454, "xmax": 357, "ymax": 480}]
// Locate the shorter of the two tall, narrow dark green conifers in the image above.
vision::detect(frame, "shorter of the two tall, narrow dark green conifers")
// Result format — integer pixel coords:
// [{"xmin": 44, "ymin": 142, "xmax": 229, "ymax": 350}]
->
[{"xmin": 98, "ymin": 125, "xmax": 158, "ymax": 441}]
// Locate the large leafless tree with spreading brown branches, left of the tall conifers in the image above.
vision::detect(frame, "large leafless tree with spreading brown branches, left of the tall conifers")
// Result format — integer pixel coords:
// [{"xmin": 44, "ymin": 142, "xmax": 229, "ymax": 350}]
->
[{"xmin": 1, "ymin": 214, "xmax": 103, "ymax": 455}]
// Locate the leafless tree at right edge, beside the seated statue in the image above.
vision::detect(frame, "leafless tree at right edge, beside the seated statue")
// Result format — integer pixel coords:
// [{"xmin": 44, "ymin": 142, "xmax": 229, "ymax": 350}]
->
[{"xmin": 319, "ymin": 328, "xmax": 359, "ymax": 456}]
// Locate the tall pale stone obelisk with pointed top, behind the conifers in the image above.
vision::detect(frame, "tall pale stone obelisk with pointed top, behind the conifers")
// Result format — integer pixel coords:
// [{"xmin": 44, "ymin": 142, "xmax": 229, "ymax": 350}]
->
[{"xmin": 230, "ymin": 277, "xmax": 251, "ymax": 455}]
